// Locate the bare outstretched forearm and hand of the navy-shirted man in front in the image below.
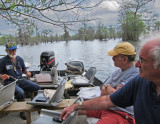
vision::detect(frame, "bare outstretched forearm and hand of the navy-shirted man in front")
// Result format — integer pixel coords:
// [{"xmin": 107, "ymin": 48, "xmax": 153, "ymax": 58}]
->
[{"xmin": 61, "ymin": 95, "xmax": 115, "ymax": 120}]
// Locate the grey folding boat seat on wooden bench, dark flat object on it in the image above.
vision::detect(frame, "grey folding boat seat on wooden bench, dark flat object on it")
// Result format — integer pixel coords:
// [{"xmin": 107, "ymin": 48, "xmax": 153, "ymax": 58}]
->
[{"xmin": 27, "ymin": 79, "xmax": 66, "ymax": 107}]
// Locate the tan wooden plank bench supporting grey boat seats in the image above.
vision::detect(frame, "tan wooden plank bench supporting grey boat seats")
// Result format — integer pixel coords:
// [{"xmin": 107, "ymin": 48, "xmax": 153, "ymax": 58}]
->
[{"xmin": 0, "ymin": 99, "xmax": 76, "ymax": 124}]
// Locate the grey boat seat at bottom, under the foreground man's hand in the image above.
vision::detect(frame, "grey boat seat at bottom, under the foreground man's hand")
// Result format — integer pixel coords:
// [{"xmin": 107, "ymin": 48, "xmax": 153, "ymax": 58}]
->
[{"xmin": 32, "ymin": 97, "xmax": 83, "ymax": 124}]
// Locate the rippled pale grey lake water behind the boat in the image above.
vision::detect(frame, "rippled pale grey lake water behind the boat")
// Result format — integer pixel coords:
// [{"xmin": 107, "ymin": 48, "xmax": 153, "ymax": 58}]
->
[{"xmin": 0, "ymin": 39, "xmax": 139, "ymax": 81}]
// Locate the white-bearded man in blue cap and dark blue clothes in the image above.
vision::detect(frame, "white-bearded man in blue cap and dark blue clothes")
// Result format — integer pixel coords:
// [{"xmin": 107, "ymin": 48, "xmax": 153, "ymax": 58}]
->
[{"xmin": 0, "ymin": 42, "xmax": 40, "ymax": 119}]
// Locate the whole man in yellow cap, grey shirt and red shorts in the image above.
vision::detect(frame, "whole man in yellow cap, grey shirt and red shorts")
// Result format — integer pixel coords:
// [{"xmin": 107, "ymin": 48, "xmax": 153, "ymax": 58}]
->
[{"xmin": 79, "ymin": 42, "xmax": 139, "ymax": 124}]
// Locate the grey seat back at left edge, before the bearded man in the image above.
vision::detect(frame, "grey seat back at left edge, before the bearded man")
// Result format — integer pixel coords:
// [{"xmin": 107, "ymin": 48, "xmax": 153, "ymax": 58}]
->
[{"xmin": 0, "ymin": 81, "xmax": 16, "ymax": 110}]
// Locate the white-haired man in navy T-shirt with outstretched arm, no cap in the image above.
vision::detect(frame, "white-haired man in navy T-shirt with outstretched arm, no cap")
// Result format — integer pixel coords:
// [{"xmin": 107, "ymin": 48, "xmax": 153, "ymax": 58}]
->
[{"xmin": 61, "ymin": 37, "xmax": 160, "ymax": 124}]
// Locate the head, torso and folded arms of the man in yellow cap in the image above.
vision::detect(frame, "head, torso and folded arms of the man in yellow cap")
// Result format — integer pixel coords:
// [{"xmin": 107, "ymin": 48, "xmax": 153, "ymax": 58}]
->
[{"xmin": 101, "ymin": 42, "xmax": 139, "ymax": 95}]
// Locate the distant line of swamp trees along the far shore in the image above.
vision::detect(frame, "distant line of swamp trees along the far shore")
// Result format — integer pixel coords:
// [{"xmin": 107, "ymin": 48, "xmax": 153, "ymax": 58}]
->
[{"xmin": 0, "ymin": 24, "xmax": 121, "ymax": 45}]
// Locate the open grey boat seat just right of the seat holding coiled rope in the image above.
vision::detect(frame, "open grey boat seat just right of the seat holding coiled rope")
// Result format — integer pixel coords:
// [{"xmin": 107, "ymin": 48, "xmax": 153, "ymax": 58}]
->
[{"xmin": 72, "ymin": 67, "xmax": 96, "ymax": 86}]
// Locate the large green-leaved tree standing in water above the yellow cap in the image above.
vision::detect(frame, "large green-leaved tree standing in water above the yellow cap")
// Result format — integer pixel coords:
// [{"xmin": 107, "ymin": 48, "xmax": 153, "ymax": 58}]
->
[{"xmin": 119, "ymin": 0, "xmax": 155, "ymax": 41}]
